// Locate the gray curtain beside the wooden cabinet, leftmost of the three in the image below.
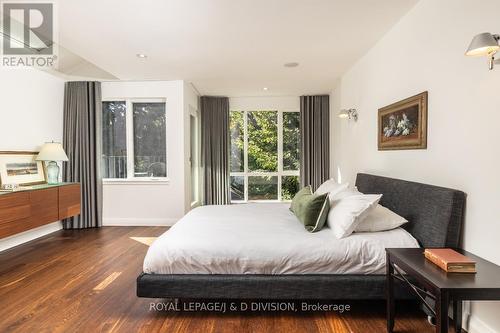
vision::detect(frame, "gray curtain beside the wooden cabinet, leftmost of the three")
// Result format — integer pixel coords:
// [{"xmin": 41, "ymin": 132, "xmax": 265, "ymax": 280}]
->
[{"xmin": 63, "ymin": 82, "xmax": 102, "ymax": 229}]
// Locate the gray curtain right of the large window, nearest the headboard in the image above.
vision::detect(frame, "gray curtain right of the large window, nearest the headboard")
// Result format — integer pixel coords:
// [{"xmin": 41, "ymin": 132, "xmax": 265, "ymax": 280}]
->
[{"xmin": 300, "ymin": 95, "xmax": 330, "ymax": 190}]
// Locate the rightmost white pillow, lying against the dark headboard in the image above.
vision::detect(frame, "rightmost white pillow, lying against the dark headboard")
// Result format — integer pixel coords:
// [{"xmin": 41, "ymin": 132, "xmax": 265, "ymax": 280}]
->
[{"xmin": 354, "ymin": 205, "xmax": 408, "ymax": 232}]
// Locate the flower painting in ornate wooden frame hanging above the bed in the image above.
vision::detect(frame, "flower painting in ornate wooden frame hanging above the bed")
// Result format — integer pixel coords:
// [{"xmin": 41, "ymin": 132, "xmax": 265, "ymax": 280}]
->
[{"xmin": 377, "ymin": 91, "xmax": 429, "ymax": 151}]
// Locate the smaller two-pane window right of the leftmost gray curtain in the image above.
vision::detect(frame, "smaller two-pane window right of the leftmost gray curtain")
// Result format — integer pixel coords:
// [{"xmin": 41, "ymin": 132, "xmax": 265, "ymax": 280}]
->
[{"xmin": 102, "ymin": 100, "xmax": 167, "ymax": 179}]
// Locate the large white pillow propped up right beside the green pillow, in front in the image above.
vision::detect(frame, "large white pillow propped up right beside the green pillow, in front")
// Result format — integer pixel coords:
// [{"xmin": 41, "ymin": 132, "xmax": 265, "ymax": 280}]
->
[{"xmin": 327, "ymin": 194, "xmax": 382, "ymax": 239}]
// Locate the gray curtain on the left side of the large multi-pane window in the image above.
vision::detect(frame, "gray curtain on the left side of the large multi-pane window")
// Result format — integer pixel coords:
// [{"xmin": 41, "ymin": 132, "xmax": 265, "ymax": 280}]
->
[{"xmin": 201, "ymin": 96, "xmax": 230, "ymax": 205}]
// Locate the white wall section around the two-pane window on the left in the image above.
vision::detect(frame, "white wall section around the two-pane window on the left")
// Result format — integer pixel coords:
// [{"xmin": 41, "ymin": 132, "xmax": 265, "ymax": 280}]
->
[{"xmin": 102, "ymin": 81, "xmax": 189, "ymax": 225}]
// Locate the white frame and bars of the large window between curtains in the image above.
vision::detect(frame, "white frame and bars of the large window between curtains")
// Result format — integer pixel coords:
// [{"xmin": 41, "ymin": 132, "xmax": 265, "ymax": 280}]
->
[{"xmin": 229, "ymin": 108, "xmax": 300, "ymax": 203}]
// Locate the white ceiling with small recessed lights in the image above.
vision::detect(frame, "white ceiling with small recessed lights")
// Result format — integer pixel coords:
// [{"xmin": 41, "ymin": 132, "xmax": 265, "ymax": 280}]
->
[{"xmin": 57, "ymin": 0, "xmax": 417, "ymax": 96}]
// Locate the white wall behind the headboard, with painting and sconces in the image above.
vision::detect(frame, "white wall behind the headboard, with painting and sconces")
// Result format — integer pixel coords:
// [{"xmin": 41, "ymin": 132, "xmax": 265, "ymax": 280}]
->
[{"xmin": 332, "ymin": 0, "xmax": 500, "ymax": 333}]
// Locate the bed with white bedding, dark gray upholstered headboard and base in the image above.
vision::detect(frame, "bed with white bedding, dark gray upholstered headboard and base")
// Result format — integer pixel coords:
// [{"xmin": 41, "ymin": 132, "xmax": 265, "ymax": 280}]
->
[{"xmin": 137, "ymin": 174, "xmax": 465, "ymax": 300}]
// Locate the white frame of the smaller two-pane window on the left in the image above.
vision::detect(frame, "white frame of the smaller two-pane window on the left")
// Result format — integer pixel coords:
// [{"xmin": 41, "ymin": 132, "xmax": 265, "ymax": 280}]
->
[{"xmin": 101, "ymin": 97, "xmax": 170, "ymax": 185}]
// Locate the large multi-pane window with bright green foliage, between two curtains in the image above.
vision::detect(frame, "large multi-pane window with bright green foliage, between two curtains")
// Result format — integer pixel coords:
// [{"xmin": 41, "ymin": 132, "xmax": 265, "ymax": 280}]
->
[{"xmin": 230, "ymin": 110, "xmax": 300, "ymax": 201}]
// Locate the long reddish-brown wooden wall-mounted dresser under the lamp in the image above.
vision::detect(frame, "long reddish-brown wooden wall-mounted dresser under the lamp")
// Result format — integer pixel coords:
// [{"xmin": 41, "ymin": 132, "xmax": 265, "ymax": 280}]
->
[{"xmin": 0, "ymin": 183, "xmax": 81, "ymax": 238}]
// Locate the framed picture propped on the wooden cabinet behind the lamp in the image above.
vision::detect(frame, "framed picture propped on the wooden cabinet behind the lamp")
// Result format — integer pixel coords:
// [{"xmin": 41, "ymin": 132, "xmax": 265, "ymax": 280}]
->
[{"xmin": 0, "ymin": 151, "xmax": 47, "ymax": 186}]
